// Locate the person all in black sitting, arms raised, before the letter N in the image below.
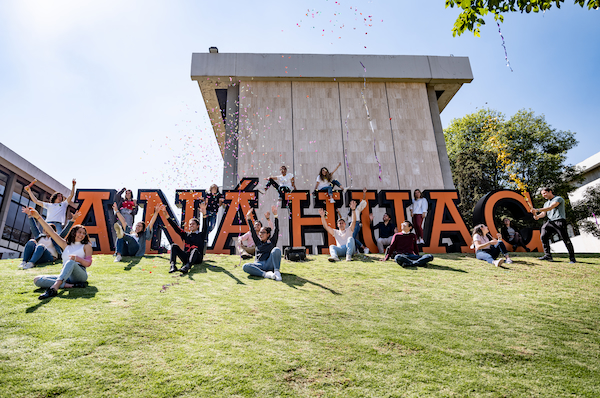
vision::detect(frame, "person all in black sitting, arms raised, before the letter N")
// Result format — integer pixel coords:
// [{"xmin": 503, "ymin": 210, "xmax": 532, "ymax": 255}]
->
[{"xmin": 161, "ymin": 202, "xmax": 208, "ymax": 274}]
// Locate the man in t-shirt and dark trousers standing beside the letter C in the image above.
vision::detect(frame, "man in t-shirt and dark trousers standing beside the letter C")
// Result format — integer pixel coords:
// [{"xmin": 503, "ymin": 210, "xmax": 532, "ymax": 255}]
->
[{"xmin": 533, "ymin": 187, "xmax": 577, "ymax": 263}]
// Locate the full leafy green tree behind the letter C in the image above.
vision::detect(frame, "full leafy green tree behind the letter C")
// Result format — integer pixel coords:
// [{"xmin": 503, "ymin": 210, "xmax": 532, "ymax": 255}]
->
[{"xmin": 444, "ymin": 109, "xmax": 577, "ymax": 230}]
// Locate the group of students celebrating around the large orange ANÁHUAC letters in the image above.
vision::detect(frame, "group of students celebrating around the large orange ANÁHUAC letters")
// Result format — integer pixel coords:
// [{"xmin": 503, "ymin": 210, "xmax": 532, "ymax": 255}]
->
[{"xmin": 20, "ymin": 169, "xmax": 576, "ymax": 299}]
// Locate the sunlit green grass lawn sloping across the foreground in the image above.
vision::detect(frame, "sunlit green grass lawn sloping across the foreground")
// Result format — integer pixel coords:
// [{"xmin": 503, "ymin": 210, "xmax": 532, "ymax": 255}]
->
[{"xmin": 0, "ymin": 253, "xmax": 600, "ymax": 397}]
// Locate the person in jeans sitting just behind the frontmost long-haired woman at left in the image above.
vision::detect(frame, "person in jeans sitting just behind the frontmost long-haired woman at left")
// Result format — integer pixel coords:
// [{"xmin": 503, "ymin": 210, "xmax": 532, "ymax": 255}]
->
[{"xmin": 19, "ymin": 207, "xmax": 81, "ymax": 269}]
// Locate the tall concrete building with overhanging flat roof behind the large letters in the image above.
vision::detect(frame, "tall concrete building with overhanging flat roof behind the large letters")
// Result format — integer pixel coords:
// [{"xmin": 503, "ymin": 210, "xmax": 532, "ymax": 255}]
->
[{"xmin": 191, "ymin": 48, "xmax": 473, "ymax": 190}]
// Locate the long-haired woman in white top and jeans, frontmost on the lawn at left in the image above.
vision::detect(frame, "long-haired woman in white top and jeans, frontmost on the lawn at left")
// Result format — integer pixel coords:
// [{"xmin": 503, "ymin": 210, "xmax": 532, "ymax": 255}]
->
[{"xmin": 24, "ymin": 207, "xmax": 93, "ymax": 300}]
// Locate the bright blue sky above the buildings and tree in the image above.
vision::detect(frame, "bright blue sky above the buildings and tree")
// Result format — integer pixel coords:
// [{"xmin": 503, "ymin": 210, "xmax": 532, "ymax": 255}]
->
[{"xmin": 0, "ymin": 0, "xmax": 600, "ymax": 200}]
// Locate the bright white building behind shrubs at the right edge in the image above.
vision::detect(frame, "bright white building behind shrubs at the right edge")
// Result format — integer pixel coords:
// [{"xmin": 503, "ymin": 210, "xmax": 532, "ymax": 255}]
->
[{"xmin": 550, "ymin": 152, "xmax": 600, "ymax": 253}]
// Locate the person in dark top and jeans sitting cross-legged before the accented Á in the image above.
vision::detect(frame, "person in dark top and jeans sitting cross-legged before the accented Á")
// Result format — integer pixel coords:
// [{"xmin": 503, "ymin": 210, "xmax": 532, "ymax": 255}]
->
[{"xmin": 242, "ymin": 206, "xmax": 282, "ymax": 282}]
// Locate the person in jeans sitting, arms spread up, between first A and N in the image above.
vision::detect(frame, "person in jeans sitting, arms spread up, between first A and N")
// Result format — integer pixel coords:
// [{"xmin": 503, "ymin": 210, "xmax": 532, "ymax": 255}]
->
[{"xmin": 113, "ymin": 203, "xmax": 166, "ymax": 263}]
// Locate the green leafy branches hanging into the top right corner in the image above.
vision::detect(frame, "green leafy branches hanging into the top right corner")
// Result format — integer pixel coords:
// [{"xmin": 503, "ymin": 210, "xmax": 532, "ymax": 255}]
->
[{"xmin": 446, "ymin": 0, "xmax": 600, "ymax": 37}]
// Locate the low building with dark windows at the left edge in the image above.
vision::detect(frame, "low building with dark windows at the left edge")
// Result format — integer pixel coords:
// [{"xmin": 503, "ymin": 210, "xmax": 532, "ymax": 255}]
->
[{"xmin": 0, "ymin": 143, "xmax": 71, "ymax": 258}]
